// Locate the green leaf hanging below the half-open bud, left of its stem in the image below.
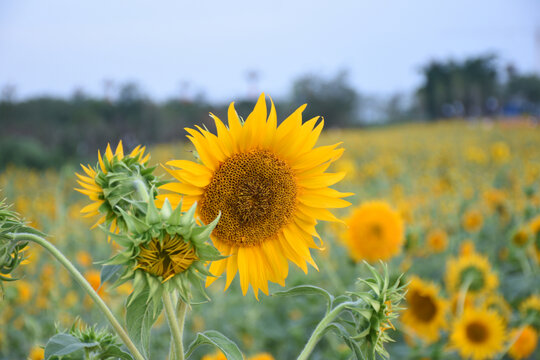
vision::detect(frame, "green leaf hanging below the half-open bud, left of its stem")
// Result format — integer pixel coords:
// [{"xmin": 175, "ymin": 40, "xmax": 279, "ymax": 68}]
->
[{"xmin": 126, "ymin": 288, "xmax": 163, "ymax": 357}]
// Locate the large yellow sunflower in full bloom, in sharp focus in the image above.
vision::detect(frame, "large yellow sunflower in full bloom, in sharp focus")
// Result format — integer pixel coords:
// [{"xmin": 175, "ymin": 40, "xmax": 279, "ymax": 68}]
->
[{"xmin": 160, "ymin": 94, "xmax": 351, "ymax": 297}]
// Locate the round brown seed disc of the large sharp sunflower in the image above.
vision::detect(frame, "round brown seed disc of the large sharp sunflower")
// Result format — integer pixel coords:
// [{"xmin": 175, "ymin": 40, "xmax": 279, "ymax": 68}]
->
[{"xmin": 199, "ymin": 150, "xmax": 297, "ymax": 246}]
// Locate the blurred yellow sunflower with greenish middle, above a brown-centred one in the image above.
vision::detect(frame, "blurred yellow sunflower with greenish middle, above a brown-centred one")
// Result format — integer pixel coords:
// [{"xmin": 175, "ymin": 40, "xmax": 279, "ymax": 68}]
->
[{"xmin": 446, "ymin": 253, "xmax": 499, "ymax": 295}]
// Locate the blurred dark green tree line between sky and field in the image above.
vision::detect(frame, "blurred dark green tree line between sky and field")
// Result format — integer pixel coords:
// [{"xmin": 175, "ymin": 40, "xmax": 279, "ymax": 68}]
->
[{"xmin": 0, "ymin": 55, "xmax": 540, "ymax": 170}]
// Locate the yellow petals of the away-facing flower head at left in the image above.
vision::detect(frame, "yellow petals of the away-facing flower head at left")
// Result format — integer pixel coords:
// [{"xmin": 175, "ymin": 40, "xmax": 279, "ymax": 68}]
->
[{"xmin": 75, "ymin": 141, "xmax": 150, "ymax": 232}]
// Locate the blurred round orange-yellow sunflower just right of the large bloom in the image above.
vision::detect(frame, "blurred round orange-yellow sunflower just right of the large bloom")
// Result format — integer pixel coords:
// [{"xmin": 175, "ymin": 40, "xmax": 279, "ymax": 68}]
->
[{"xmin": 345, "ymin": 201, "xmax": 405, "ymax": 262}]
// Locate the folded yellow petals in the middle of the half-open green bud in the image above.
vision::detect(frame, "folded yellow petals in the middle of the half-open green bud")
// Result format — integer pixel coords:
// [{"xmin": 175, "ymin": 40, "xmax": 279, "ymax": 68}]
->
[{"xmin": 137, "ymin": 235, "xmax": 197, "ymax": 280}]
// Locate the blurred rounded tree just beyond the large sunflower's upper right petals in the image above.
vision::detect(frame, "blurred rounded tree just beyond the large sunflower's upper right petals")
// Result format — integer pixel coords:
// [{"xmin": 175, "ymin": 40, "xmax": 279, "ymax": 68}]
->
[{"xmin": 292, "ymin": 71, "xmax": 359, "ymax": 127}]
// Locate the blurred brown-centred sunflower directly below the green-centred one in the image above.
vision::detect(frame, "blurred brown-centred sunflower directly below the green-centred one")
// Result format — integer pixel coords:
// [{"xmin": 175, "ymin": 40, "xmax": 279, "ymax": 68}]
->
[{"xmin": 450, "ymin": 308, "xmax": 505, "ymax": 360}]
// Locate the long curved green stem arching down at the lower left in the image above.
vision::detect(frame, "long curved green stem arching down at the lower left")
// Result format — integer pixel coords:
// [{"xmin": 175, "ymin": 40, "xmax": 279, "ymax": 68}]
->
[{"xmin": 10, "ymin": 233, "xmax": 145, "ymax": 360}]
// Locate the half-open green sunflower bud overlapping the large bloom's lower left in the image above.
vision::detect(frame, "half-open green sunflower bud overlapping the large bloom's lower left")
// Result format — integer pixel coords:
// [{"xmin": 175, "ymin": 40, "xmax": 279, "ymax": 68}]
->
[{"xmin": 106, "ymin": 197, "xmax": 222, "ymax": 303}]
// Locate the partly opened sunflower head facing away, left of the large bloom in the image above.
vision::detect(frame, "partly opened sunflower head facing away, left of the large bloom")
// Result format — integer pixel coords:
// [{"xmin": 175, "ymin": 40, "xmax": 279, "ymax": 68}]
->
[{"xmin": 75, "ymin": 141, "xmax": 158, "ymax": 236}]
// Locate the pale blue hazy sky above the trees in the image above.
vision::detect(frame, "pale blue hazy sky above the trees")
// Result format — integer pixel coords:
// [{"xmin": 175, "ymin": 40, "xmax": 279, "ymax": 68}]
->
[{"xmin": 0, "ymin": 0, "xmax": 540, "ymax": 101}]
